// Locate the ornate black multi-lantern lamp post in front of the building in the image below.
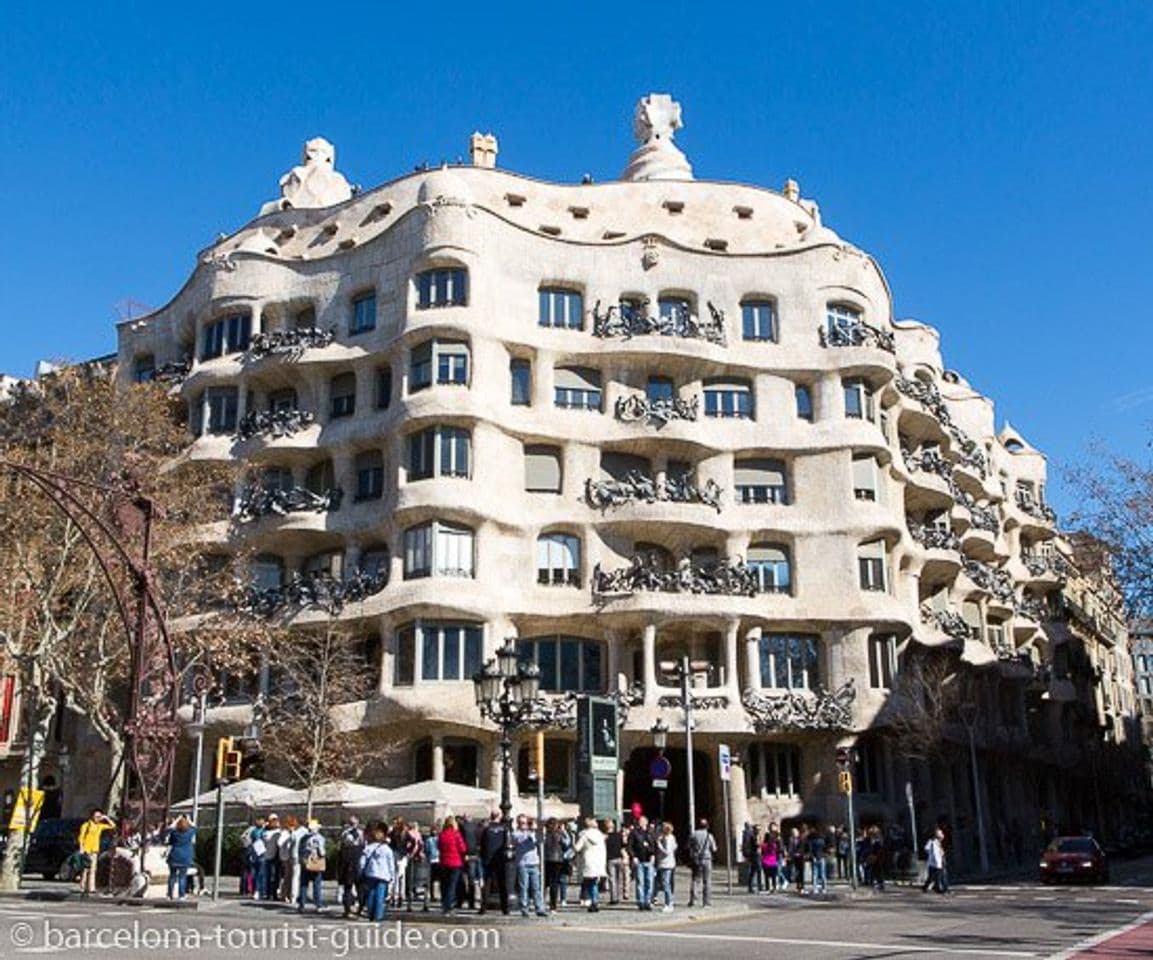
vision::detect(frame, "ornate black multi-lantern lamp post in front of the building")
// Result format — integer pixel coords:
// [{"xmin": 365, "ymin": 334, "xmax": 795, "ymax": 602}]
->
[{"xmin": 473, "ymin": 637, "xmax": 562, "ymax": 860}]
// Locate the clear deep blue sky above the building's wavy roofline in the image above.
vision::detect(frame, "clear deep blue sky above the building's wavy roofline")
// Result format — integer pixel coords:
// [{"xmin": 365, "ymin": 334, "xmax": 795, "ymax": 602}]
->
[{"xmin": 0, "ymin": 0, "xmax": 1153, "ymax": 511}]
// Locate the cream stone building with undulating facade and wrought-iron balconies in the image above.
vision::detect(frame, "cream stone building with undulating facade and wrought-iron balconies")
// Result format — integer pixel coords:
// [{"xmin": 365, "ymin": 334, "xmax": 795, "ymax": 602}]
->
[{"xmin": 119, "ymin": 95, "xmax": 1143, "ymax": 857}]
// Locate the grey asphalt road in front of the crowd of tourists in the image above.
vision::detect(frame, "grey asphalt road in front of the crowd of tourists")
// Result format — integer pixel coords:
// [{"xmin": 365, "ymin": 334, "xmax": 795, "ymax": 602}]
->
[{"xmin": 0, "ymin": 859, "xmax": 1153, "ymax": 960}]
